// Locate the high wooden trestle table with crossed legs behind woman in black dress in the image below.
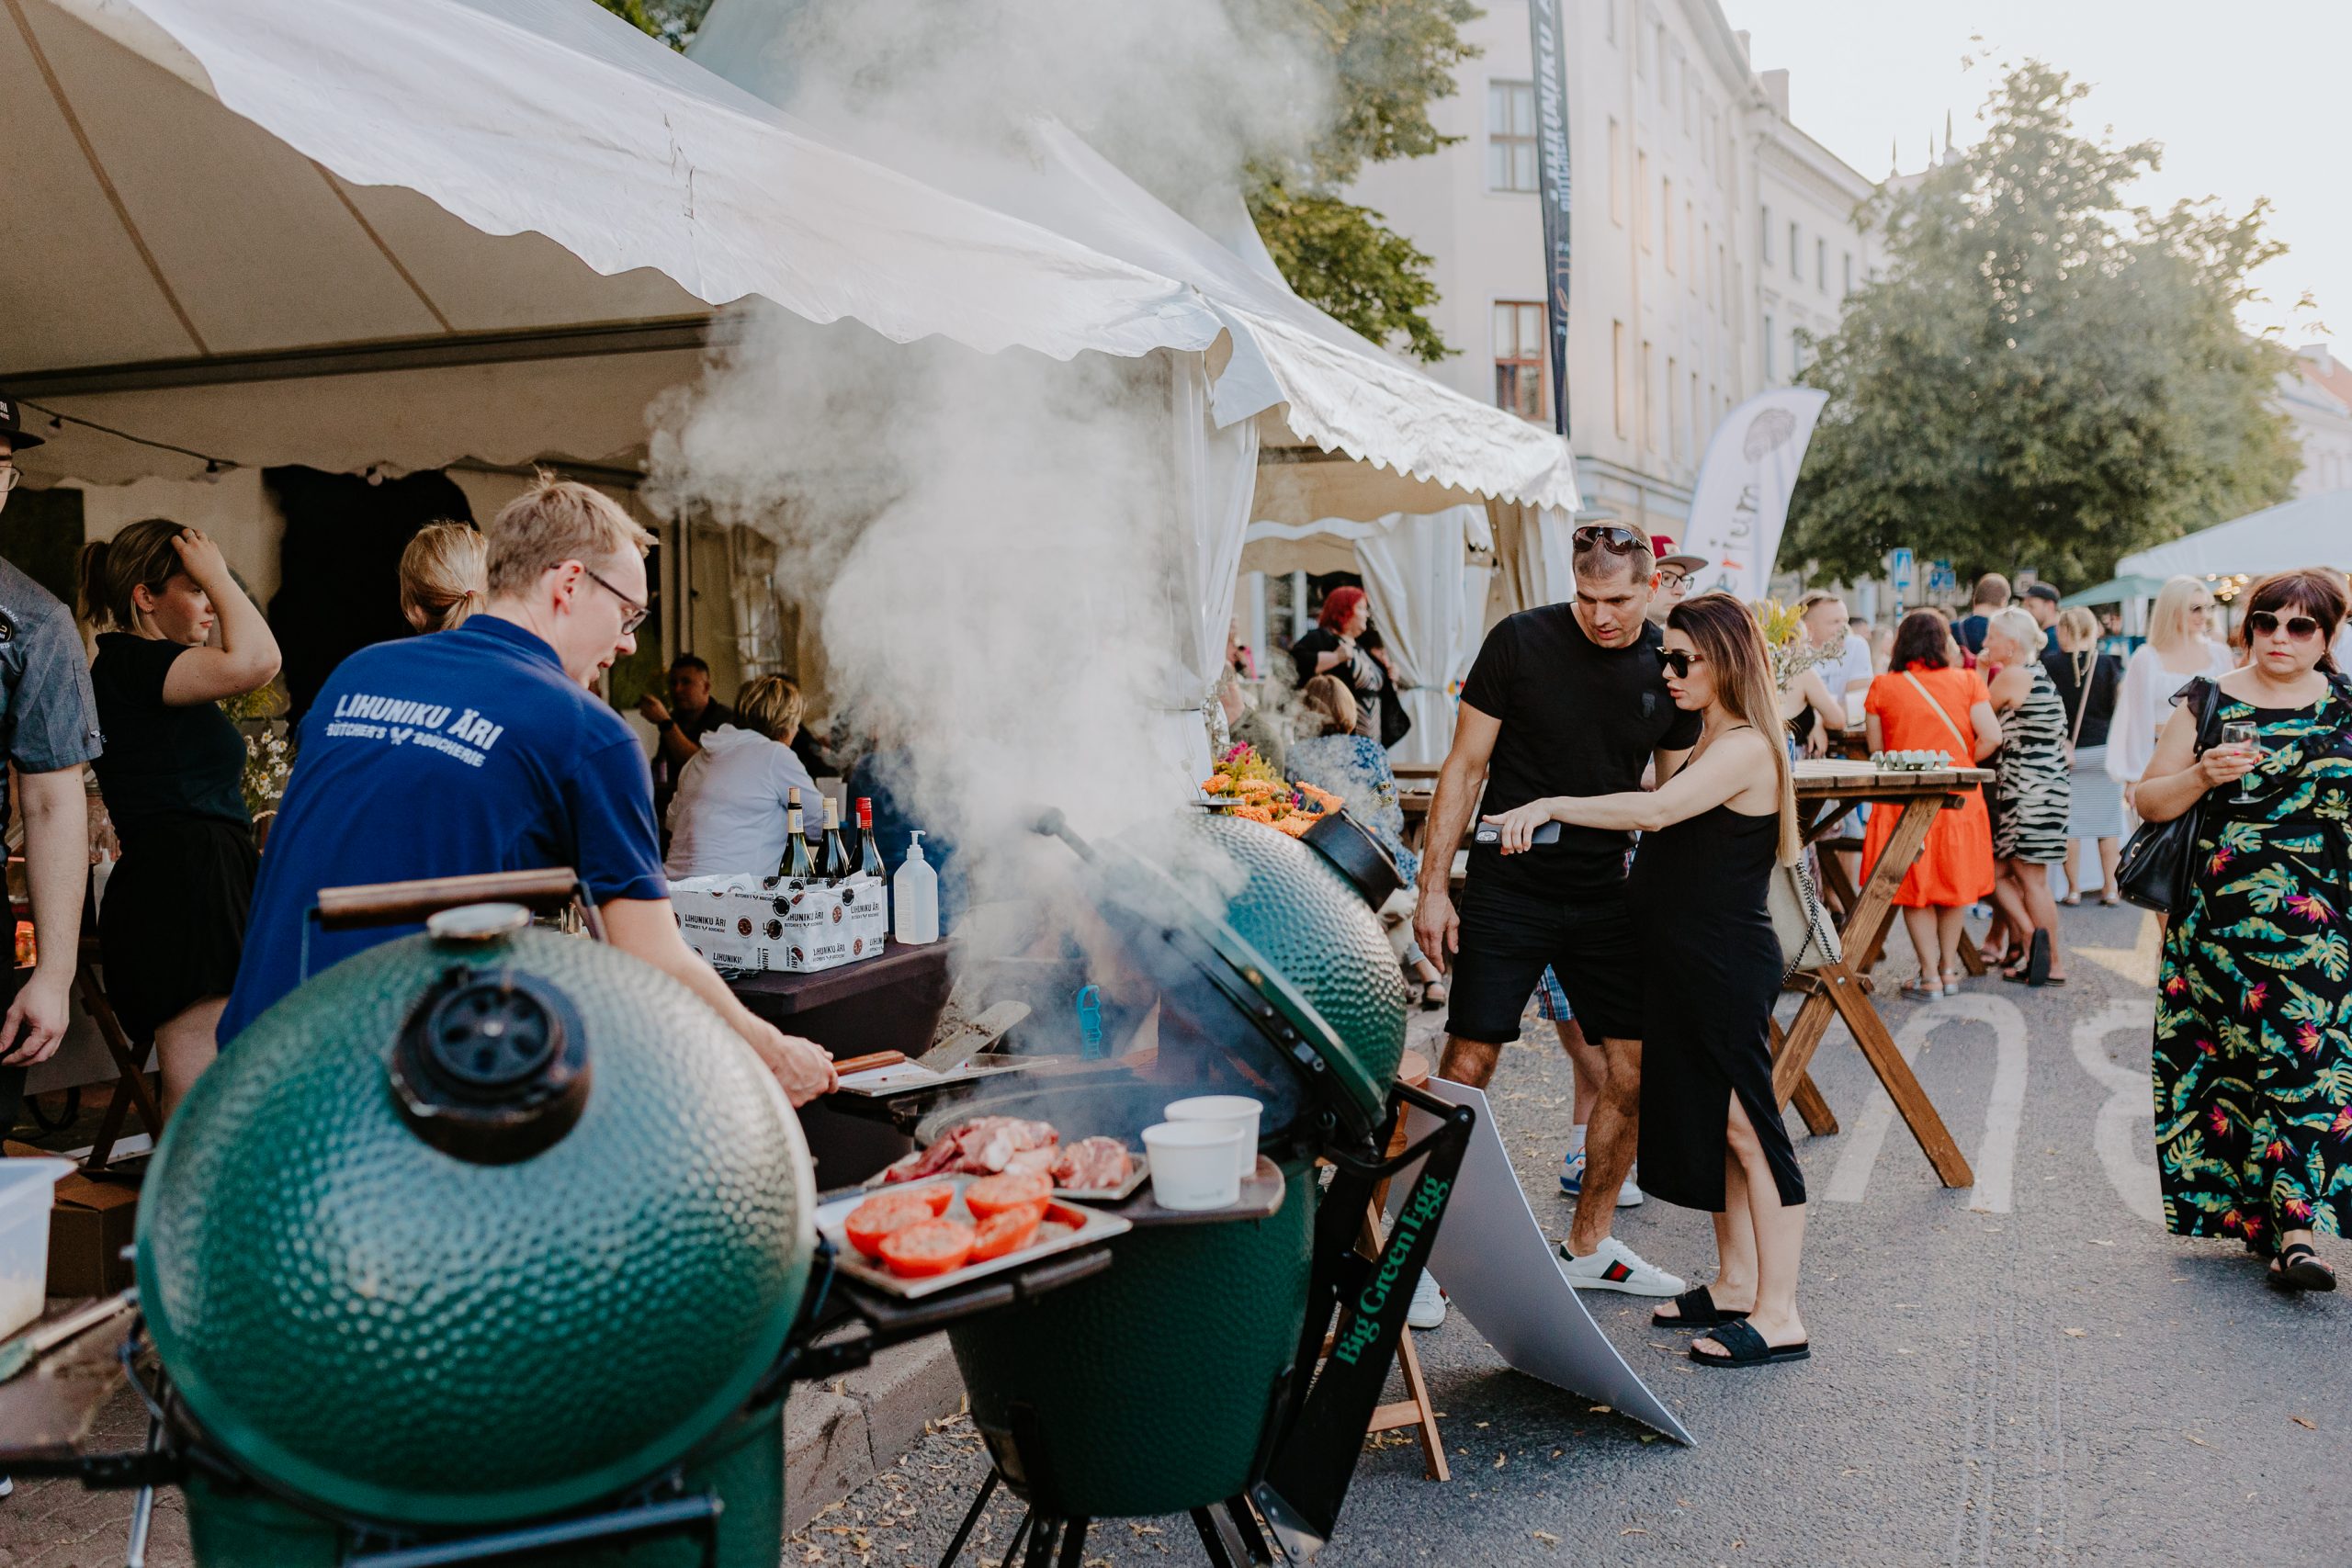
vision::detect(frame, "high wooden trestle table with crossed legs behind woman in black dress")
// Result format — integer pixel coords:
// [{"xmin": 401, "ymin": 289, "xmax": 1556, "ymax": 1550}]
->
[{"xmin": 1771, "ymin": 760, "xmax": 1992, "ymax": 1187}]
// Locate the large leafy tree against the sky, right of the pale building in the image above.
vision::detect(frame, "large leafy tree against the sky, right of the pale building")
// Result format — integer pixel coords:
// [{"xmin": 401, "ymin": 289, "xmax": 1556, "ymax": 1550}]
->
[{"xmin": 1781, "ymin": 62, "xmax": 2298, "ymax": 588}]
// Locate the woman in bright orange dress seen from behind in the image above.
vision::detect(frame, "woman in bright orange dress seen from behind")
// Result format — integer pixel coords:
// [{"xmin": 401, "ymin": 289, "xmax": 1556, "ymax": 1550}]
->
[{"xmin": 1863, "ymin": 609, "xmax": 2002, "ymax": 997}]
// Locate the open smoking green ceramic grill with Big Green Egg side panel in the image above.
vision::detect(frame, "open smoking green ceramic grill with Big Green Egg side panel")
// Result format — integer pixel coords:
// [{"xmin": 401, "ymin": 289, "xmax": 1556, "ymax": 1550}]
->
[{"xmin": 917, "ymin": 816, "xmax": 1467, "ymax": 1561}]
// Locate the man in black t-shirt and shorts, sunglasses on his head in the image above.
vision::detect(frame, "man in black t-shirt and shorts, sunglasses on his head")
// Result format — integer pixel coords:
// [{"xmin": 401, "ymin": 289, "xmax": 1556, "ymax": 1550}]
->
[{"xmin": 1414, "ymin": 525, "xmax": 1698, "ymax": 1295}]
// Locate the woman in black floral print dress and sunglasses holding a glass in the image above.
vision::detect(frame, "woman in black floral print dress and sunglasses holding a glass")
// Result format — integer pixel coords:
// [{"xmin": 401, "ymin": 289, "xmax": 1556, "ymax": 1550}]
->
[{"xmin": 2138, "ymin": 571, "xmax": 2352, "ymax": 1291}]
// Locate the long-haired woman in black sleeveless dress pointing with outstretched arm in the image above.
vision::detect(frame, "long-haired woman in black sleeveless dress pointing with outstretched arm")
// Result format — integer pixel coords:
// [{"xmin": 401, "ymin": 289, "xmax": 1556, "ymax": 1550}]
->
[{"xmin": 1488, "ymin": 592, "xmax": 1811, "ymax": 1366}]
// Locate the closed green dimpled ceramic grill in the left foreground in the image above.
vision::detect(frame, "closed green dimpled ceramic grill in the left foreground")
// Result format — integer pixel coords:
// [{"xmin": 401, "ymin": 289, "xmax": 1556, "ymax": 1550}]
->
[{"xmin": 139, "ymin": 905, "xmax": 816, "ymax": 1568}]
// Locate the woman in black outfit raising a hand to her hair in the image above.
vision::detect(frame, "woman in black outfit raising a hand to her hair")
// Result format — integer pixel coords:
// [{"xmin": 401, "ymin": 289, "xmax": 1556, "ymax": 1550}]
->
[{"xmin": 83, "ymin": 517, "xmax": 277, "ymax": 1117}]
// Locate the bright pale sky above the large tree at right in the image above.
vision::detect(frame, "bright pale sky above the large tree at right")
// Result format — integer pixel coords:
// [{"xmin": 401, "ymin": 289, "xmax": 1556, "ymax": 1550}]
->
[{"xmin": 1722, "ymin": 0, "xmax": 2352, "ymax": 345}]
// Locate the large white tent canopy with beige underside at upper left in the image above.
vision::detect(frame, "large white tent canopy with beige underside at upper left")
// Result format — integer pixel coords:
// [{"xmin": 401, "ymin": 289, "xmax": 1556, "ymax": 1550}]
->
[{"xmin": 0, "ymin": 0, "xmax": 1226, "ymax": 482}]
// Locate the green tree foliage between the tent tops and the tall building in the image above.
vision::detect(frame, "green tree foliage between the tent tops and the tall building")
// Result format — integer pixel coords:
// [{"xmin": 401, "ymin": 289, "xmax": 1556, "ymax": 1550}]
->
[{"xmin": 1227, "ymin": 0, "xmax": 1484, "ymax": 360}]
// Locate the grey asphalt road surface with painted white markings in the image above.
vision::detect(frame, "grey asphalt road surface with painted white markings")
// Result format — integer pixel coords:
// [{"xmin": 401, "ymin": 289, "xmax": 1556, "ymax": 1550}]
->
[{"xmin": 783, "ymin": 908, "xmax": 2352, "ymax": 1568}]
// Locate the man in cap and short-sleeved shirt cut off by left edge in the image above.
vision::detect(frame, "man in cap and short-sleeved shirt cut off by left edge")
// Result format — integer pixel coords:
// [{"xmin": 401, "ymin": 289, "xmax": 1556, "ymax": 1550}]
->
[{"xmin": 0, "ymin": 392, "xmax": 99, "ymax": 1131}]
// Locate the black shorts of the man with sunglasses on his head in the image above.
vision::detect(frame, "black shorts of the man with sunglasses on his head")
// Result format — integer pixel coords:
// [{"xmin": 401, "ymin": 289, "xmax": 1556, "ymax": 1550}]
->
[{"xmin": 1446, "ymin": 874, "xmax": 1642, "ymax": 1046}]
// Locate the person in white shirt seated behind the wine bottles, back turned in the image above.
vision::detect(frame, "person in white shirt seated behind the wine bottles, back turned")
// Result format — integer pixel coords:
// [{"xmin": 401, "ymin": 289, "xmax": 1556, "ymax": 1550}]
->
[{"xmin": 663, "ymin": 674, "xmax": 823, "ymax": 882}]
